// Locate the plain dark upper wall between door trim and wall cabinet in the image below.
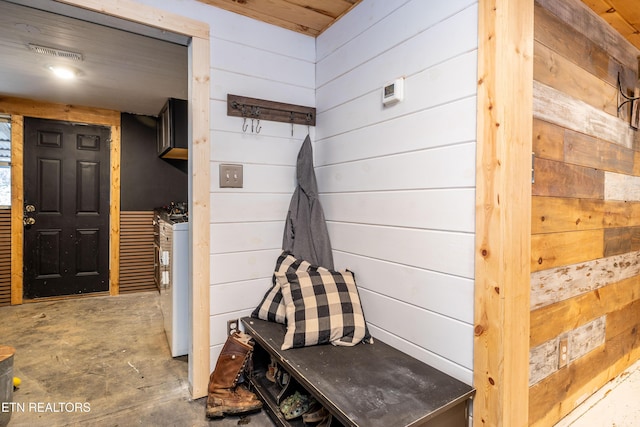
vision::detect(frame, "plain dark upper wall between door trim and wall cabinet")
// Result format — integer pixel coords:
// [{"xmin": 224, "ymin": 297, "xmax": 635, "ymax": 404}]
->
[{"xmin": 120, "ymin": 114, "xmax": 188, "ymax": 211}]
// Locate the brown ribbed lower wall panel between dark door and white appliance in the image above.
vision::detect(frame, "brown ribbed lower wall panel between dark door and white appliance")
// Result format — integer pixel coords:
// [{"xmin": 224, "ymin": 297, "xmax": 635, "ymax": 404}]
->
[{"xmin": 120, "ymin": 211, "xmax": 157, "ymax": 294}]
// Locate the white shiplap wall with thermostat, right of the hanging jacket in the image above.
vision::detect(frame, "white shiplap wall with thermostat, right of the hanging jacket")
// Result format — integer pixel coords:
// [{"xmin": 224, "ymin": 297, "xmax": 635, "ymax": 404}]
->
[{"xmin": 315, "ymin": 0, "xmax": 478, "ymax": 384}]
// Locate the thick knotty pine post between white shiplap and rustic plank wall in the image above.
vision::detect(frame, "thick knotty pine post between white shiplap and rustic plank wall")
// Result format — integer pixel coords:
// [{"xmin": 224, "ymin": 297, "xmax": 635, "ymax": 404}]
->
[{"xmin": 473, "ymin": 0, "xmax": 534, "ymax": 426}]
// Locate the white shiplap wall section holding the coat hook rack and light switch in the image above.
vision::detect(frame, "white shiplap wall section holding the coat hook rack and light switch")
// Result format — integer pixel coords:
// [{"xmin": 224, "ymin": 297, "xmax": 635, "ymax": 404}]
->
[{"xmin": 143, "ymin": 0, "xmax": 315, "ymax": 369}]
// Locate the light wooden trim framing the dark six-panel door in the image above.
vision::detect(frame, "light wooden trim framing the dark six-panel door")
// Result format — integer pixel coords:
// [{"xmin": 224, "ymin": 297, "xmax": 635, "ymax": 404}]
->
[{"xmin": 0, "ymin": 97, "xmax": 120, "ymax": 305}]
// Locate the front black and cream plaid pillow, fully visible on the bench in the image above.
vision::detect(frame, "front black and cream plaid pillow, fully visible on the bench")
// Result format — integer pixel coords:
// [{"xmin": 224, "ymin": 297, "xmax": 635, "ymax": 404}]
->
[{"xmin": 276, "ymin": 269, "xmax": 373, "ymax": 350}]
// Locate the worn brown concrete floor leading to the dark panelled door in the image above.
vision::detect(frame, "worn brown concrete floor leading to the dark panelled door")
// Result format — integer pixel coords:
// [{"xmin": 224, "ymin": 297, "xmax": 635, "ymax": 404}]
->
[{"xmin": 0, "ymin": 292, "xmax": 274, "ymax": 427}]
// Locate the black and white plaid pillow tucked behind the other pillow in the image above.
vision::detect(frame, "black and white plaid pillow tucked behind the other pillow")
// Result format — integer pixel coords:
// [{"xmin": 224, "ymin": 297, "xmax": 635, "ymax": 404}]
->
[{"xmin": 251, "ymin": 251, "xmax": 311, "ymax": 323}]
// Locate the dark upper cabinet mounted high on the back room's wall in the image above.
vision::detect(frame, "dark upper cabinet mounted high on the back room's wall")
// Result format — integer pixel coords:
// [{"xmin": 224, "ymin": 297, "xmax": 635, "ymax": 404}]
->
[{"xmin": 158, "ymin": 98, "xmax": 189, "ymax": 160}]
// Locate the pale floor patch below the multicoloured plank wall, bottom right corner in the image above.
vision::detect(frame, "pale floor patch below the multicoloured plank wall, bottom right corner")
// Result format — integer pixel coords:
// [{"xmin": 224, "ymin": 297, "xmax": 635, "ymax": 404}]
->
[{"xmin": 555, "ymin": 361, "xmax": 640, "ymax": 427}]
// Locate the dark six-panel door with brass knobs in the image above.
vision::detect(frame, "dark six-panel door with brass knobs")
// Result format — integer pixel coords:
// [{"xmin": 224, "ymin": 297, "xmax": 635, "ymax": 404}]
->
[{"xmin": 23, "ymin": 118, "xmax": 110, "ymax": 299}]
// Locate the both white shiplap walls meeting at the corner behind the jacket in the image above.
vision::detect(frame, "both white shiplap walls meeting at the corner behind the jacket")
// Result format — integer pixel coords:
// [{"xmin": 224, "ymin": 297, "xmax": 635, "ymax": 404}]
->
[{"xmin": 139, "ymin": 0, "xmax": 477, "ymax": 384}]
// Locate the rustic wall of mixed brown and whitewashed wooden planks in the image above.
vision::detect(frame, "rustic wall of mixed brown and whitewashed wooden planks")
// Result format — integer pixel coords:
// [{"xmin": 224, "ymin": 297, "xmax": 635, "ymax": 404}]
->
[{"xmin": 529, "ymin": 0, "xmax": 640, "ymax": 425}]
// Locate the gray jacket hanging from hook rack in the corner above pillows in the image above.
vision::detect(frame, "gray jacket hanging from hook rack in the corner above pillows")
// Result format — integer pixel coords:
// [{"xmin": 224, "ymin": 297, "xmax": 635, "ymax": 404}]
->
[{"xmin": 282, "ymin": 135, "xmax": 333, "ymax": 270}]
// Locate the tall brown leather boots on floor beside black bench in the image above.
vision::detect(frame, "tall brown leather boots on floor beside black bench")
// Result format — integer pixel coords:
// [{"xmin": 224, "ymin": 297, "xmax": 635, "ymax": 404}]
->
[{"xmin": 206, "ymin": 332, "xmax": 262, "ymax": 418}]
